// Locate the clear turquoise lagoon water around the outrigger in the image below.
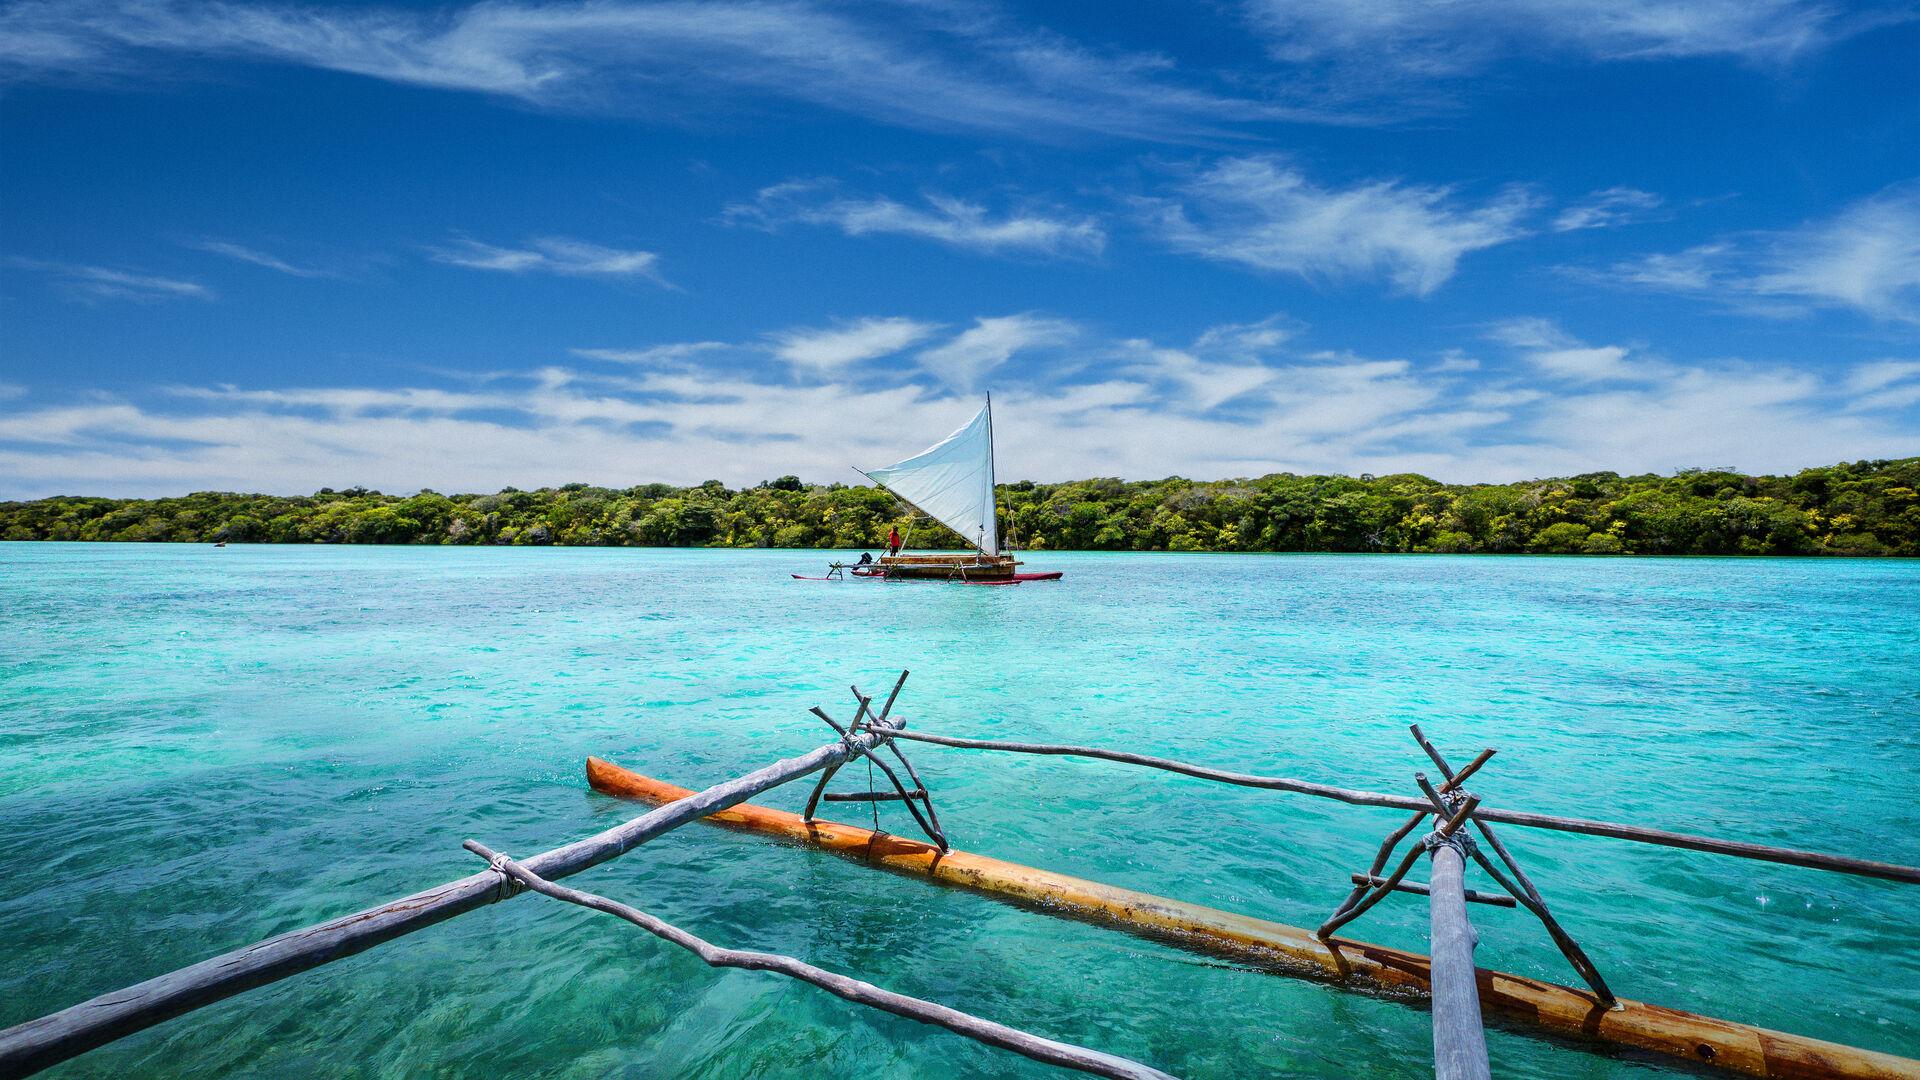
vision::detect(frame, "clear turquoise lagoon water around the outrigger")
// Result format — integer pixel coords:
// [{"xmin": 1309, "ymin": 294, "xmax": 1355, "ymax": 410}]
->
[{"xmin": 0, "ymin": 544, "xmax": 1920, "ymax": 1078}]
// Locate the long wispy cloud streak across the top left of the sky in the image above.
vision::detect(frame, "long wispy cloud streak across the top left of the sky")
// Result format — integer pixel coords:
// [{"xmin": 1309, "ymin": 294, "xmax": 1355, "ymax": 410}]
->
[{"xmin": 0, "ymin": 0, "xmax": 1351, "ymax": 140}]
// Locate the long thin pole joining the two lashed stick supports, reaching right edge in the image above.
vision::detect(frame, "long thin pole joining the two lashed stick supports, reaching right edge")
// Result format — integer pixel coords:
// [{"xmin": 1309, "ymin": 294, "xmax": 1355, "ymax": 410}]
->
[{"xmin": 891, "ymin": 730, "xmax": 1920, "ymax": 884}]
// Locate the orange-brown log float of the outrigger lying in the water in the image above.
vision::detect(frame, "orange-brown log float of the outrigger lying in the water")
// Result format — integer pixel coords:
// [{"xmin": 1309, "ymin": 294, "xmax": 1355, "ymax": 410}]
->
[{"xmin": 588, "ymin": 757, "xmax": 1920, "ymax": 1080}]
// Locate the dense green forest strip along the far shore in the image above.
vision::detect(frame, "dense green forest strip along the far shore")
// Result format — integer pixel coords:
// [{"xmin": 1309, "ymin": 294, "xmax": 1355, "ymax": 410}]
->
[{"xmin": 0, "ymin": 457, "xmax": 1920, "ymax": 555}]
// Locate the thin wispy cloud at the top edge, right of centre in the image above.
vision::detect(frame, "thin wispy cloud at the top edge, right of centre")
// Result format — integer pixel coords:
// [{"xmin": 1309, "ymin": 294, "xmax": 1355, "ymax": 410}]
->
[{"xmin": 1246, "ymin": 0, "xmax": 1872, "ymax": 77}]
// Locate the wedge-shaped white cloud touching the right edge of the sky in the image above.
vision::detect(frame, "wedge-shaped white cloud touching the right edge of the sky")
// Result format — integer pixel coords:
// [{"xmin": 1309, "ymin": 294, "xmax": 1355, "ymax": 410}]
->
[{"xmin": 1571, "ymin": 183, "xmax": 1920, "ymax": 323}]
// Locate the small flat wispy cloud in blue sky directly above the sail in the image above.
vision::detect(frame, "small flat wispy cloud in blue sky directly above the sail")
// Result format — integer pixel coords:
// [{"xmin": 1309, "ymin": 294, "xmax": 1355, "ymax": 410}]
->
[{"xmin": 726, "ymin": 181, "xmax": 1106, "ymax": 256}]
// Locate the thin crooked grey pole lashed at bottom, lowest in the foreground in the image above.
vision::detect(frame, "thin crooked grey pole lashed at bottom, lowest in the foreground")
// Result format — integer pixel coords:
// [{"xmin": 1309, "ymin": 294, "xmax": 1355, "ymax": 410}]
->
[{"xmin": 465, "ymin": 840, "xmax": 1175, "ymax": 1080}]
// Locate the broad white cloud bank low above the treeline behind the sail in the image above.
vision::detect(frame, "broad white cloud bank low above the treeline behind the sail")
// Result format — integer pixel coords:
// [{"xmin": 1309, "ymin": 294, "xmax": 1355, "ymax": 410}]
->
[{"xmin": 0, "ymin": 311, "xmax": 1920, "ymax": 498}]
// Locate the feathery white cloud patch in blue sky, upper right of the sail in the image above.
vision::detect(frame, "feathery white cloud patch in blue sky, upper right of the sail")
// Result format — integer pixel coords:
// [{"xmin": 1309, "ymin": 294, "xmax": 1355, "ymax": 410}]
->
[{"xmin": 1142, "ymin": 156, "xmax": 1534, "ymax": 296}]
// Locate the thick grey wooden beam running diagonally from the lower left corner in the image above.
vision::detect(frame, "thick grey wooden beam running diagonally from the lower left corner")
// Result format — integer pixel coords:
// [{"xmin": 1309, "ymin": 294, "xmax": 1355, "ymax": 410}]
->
[{"xmin": 0, "ymin": 732, "xmax": 891, "ymax": 1078}]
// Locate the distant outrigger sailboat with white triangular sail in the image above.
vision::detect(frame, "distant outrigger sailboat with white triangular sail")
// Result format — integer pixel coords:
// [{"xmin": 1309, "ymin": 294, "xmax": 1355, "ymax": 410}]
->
[{"xmin": 793, "ymin": 394, "xmax": 1062, "ymax": 584}]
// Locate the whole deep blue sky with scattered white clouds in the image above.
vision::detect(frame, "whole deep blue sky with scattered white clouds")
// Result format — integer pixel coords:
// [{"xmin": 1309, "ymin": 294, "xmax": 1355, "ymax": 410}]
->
[{"xmin": 0, "ymin": 0, "xmax": 1920, "ymax": 498}]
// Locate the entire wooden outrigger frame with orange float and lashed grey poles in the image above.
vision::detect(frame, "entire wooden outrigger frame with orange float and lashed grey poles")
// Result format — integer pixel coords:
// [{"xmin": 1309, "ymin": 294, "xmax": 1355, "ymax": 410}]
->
[{"xmin": 0, "ymin": 673, "xmax": 1920, "ymax": 1080}]
